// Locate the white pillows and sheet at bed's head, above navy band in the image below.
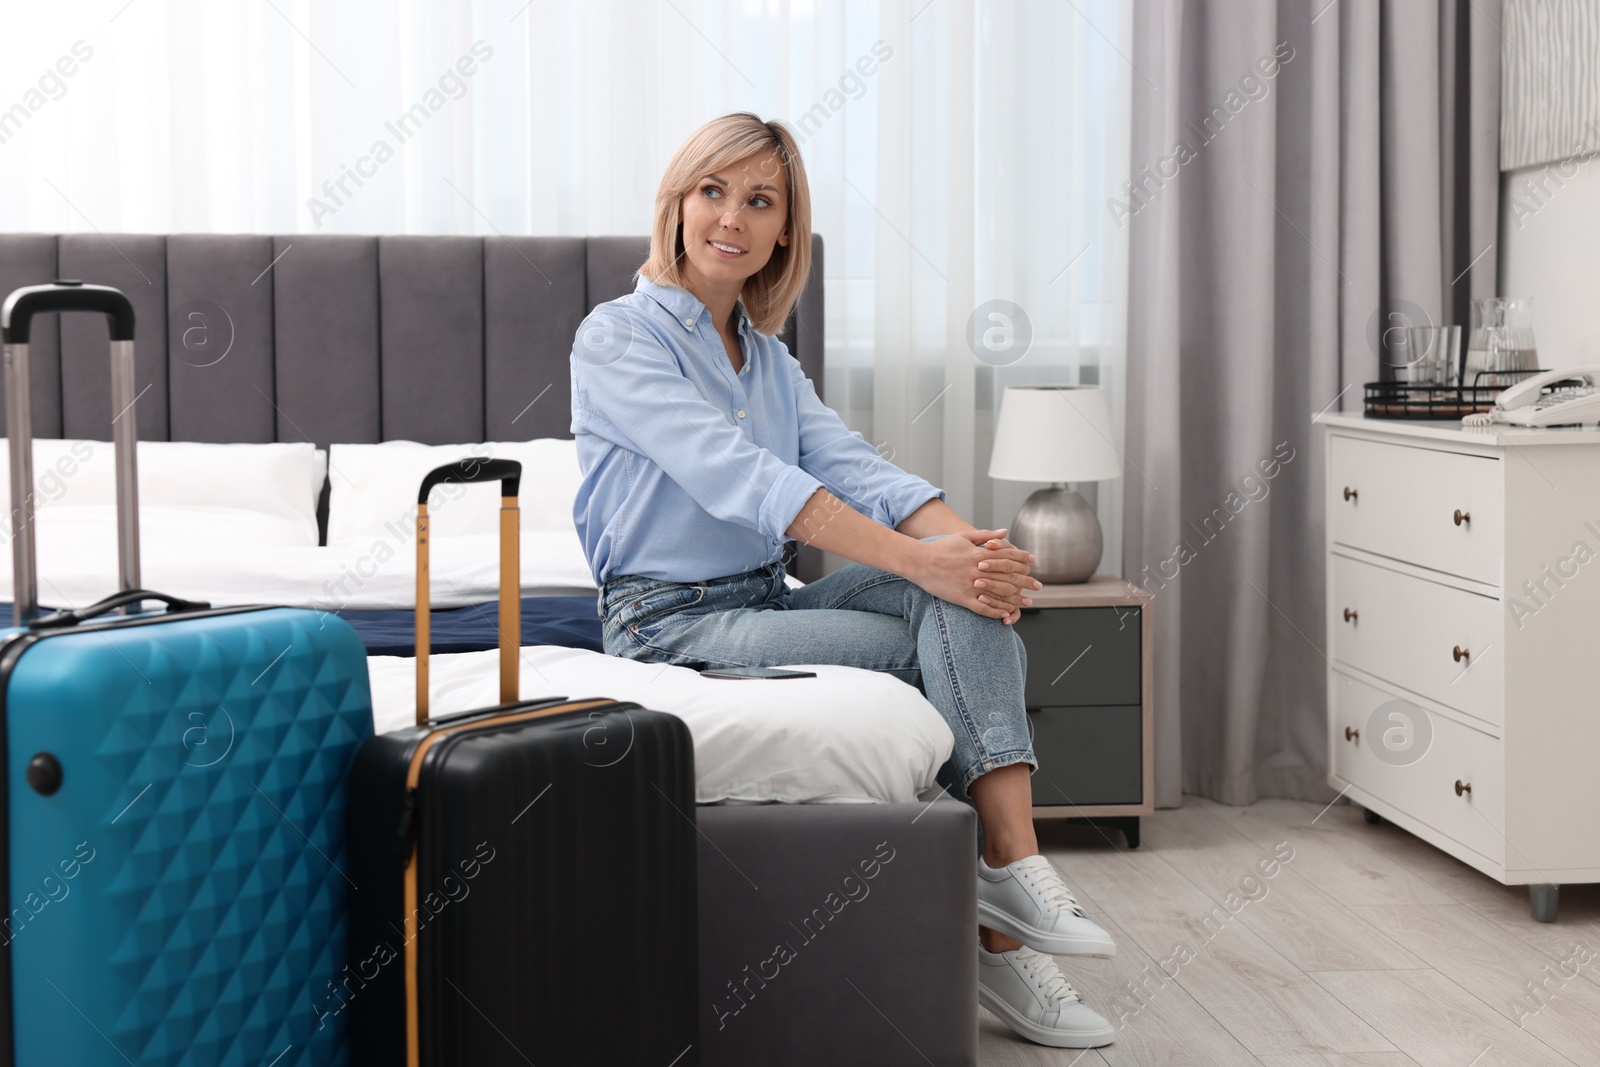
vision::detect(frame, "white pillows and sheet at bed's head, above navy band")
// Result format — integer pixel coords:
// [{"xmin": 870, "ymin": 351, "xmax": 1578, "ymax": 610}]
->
[{"xmin": 0, "ymin": 438, "xmax": 597, "ymax": 611}]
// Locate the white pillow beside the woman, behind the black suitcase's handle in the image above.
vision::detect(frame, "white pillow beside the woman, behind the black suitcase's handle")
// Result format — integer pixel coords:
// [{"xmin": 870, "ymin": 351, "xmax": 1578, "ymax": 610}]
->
[{"xmin": 328, "ymin": 438, "xmax": 582, "ymax": 545}]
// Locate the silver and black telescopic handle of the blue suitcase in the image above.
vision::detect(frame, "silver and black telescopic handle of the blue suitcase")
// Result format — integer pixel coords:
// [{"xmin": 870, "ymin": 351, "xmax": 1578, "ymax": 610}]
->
[{"xmin": 0, "ymin": 280, "xmax": 139, "ymax": 625}]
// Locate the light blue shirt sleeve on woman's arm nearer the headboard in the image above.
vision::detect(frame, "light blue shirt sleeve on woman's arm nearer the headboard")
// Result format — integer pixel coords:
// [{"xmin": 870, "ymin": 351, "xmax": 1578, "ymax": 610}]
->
[{"xmin": 571, "ymin": 307, "xmax": 822, "ymax": 541}]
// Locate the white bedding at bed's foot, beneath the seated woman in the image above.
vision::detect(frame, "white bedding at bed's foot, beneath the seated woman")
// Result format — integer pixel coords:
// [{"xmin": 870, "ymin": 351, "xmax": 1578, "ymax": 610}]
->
[{"xmin": 366, "ymin": 645, "xmax": 955, "ymax": 805}]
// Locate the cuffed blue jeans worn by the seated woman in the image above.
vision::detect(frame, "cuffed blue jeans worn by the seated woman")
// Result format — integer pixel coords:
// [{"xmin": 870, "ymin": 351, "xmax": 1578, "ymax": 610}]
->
[{"xmin": 597, "ymin": 547, "xmax": 1038, "ymax": 803}]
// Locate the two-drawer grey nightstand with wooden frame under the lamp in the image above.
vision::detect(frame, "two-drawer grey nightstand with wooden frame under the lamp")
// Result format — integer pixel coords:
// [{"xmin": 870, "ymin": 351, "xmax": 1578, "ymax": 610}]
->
[{"xmin": 1016, "ymin": 574, "xmax": 1155, "ymax": 848}]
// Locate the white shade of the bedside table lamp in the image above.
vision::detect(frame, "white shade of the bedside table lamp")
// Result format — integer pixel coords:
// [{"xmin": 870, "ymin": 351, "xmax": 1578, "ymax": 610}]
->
[{"xmin": 989, "ymin": 386, "xmax": 1122, "ymax": 482}]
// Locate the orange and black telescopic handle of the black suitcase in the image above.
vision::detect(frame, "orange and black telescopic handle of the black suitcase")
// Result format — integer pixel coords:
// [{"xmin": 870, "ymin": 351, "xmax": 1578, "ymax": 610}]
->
[{"xmin": 416, "ymin": 459, "xmax": 522, "ymax": 726}]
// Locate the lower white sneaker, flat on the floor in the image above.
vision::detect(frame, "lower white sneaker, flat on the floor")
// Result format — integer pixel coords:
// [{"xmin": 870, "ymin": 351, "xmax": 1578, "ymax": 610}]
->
[{"xmin": 978, "ymin": 945, "xmax": 1117, "ymax": 1048}]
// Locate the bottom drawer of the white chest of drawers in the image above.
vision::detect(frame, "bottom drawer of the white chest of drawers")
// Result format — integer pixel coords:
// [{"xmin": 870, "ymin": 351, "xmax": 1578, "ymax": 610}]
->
[{"xmin": 1330, "ymin": 673, "xmax": 1506, "ymax": 864}]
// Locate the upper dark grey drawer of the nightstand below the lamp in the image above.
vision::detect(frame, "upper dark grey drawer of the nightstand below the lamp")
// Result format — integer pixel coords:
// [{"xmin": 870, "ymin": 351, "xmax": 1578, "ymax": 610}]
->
[{"xmin": 1016, "ymin": 606, "xmax": 1142, "ymax": 709}]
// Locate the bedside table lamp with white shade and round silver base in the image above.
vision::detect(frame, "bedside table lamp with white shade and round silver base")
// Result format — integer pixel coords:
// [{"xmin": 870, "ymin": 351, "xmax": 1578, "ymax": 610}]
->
[{"xmin": 989, "ymin": 386, "xmax": 1122, "ymax": 584}]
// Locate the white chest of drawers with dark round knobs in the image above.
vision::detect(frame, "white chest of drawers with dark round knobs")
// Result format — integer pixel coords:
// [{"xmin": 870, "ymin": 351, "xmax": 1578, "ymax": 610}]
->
[{"xmin": 1318, "ymin": 414, "xmax": 1600, "ymax": 921}]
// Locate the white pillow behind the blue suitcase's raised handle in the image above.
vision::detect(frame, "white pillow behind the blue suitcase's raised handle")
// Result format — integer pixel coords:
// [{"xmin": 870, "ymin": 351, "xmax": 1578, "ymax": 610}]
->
[{"xmin": 0, "ymin": 438, "xmax": 328, "ymax": 545}]
